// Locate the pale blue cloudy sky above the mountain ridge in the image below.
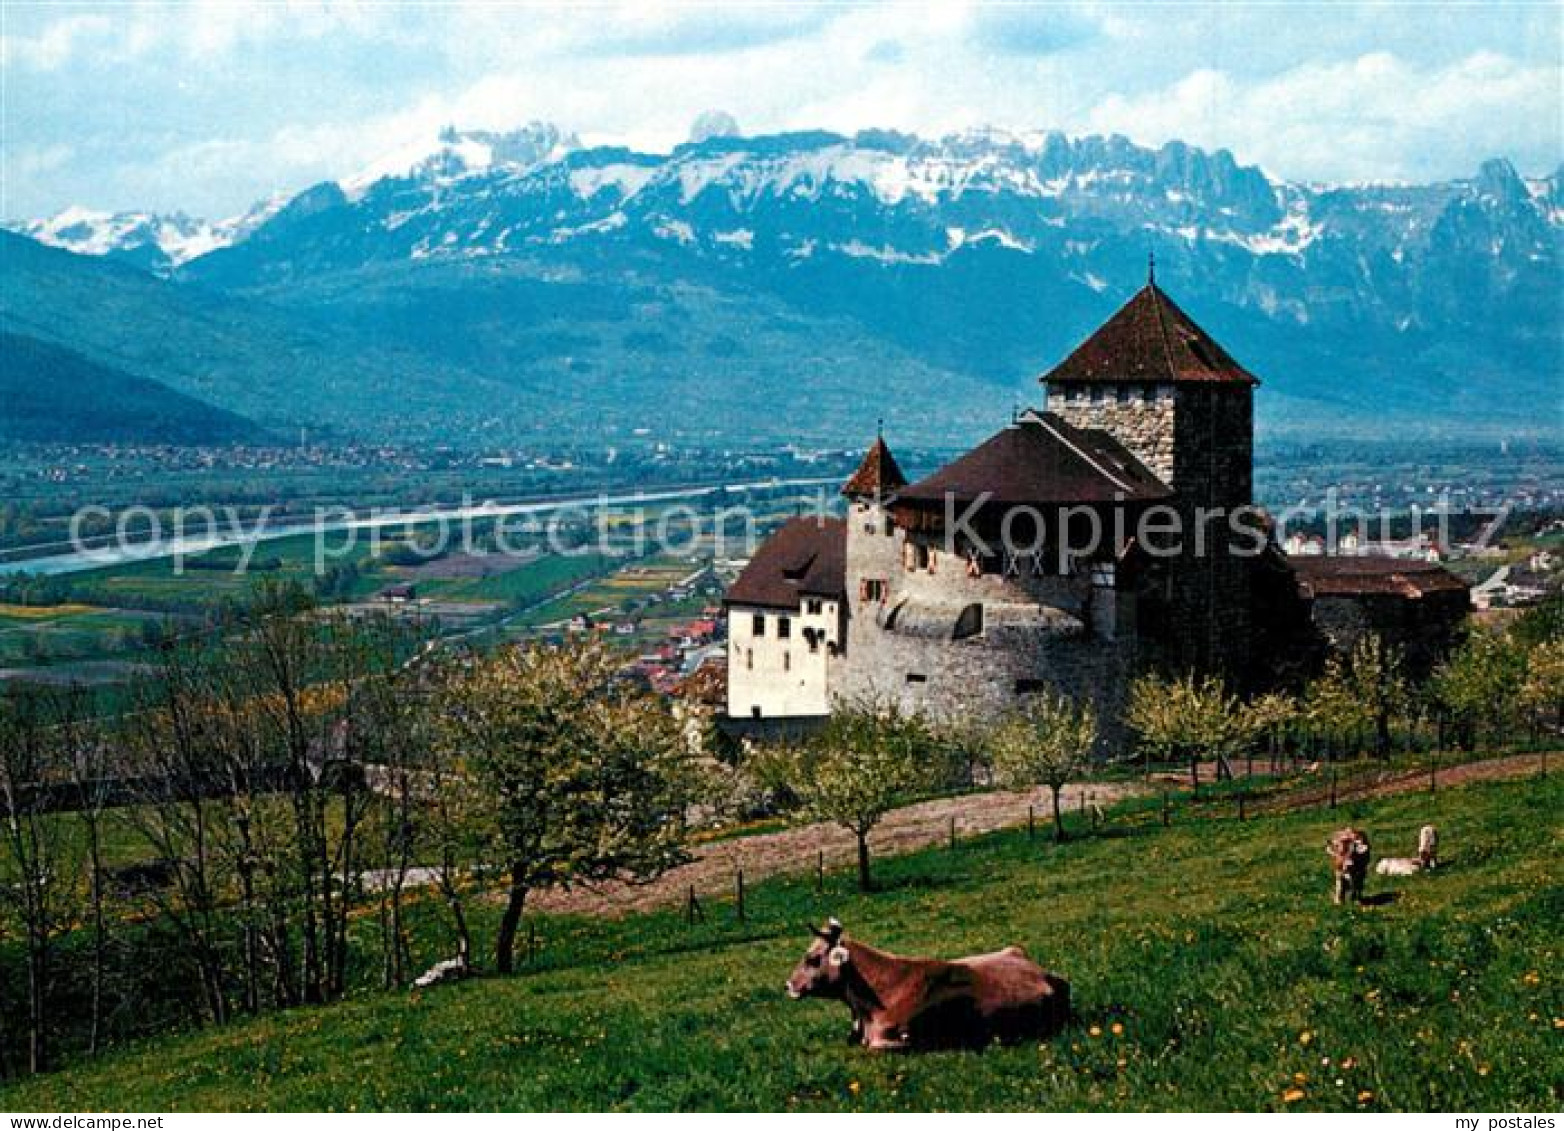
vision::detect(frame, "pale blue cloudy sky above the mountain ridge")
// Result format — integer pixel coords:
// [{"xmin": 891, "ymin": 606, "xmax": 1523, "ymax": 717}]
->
[{"xmin": 0, "ymin": 0, "xmax": 1564, "ymax": 217}]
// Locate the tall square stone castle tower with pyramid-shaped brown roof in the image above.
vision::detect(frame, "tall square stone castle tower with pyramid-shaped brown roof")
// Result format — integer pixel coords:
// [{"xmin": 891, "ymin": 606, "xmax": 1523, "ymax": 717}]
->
[{"xmin": 1042, "ymin": 277, "xmax": 1259, "ymax": 682}]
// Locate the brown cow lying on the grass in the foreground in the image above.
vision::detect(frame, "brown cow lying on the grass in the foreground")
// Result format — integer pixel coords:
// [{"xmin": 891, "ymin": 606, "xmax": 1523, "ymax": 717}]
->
[{"xmin": 787, "ymin": 920, "xmax": 1070, "ymax": 1050}]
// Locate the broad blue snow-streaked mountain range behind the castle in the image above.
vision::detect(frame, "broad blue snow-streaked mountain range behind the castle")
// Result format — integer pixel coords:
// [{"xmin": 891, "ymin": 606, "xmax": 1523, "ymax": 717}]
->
[{"xmin": 6, "ymin": 120, "xmax": 1564, "ymax": 441}]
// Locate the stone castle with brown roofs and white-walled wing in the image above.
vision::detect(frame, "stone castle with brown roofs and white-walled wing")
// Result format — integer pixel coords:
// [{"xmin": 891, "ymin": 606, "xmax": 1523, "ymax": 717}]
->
[{"xmin": 726, "ymin": 278, "xmax": 1465, "ymax": 740}]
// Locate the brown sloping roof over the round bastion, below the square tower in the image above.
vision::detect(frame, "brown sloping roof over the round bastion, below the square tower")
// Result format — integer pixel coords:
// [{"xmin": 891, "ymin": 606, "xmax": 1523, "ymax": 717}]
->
[{"xmin": 896, "ymin": 413, "xmax": 1171, "ymax": 508}]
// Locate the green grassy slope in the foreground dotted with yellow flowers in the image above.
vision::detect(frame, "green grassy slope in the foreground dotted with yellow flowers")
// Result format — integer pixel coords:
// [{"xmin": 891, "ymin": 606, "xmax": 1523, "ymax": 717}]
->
[{"xmin": 0, "ymin": 776, "xmax": 1564, "ymax": 1111}]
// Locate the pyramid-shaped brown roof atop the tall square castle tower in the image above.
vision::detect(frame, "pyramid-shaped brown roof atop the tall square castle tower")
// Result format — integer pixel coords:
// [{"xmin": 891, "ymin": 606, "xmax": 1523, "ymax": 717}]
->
[{"xmin": 1042, "ymin": 280, "xmax": 1259, "ymax": 385}]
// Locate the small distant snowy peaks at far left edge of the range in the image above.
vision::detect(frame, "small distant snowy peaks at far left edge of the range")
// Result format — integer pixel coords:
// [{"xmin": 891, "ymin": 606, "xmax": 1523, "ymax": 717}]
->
[{"xmin": 9, "ymin": 194, "xmax": 288, "ymax": 274}]
